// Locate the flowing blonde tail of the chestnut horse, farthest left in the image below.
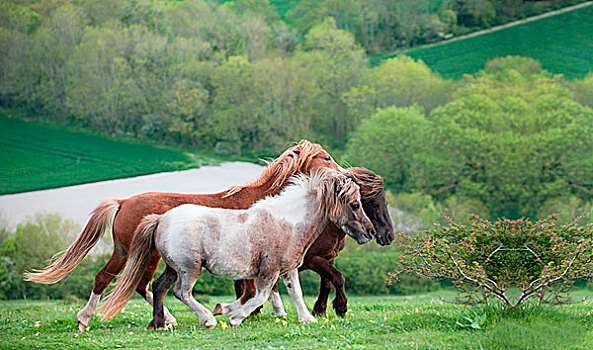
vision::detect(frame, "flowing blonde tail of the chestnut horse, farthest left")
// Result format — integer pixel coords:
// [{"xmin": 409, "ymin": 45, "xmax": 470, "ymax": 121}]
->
[{"xmin": 24, "ymin": 199, "xmax": 120, "ymax": 284}]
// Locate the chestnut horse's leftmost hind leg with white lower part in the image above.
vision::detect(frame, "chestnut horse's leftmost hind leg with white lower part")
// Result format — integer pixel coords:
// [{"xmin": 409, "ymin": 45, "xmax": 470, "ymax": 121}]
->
[{"xmin": 76, "ymin": 242, "xmax": 127, "ymax": 332}]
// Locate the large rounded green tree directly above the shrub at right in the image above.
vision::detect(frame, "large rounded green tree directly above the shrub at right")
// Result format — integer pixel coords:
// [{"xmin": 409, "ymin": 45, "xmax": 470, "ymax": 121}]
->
[{"xmin": 431, "ymin": 57, "xmax": 593, "ymax": 218}]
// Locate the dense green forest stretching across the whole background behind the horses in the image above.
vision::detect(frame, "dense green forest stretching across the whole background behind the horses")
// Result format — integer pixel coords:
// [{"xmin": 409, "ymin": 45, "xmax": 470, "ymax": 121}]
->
[{"xmin": 0, "ymin": 0, "xmax": 593, "ymax": 221}]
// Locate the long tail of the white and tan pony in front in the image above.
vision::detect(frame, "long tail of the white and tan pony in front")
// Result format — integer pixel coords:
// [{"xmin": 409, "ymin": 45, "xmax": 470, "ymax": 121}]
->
[{"xmin": 100, "ymin": 214, "xmax": 160, "ymax": 320}]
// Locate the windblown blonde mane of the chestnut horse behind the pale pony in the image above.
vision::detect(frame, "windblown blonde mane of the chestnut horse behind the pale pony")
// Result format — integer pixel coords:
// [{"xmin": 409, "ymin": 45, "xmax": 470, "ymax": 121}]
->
[{"xmin": 225, "ymin": 140, "xmax": 323, "ymax": 197}]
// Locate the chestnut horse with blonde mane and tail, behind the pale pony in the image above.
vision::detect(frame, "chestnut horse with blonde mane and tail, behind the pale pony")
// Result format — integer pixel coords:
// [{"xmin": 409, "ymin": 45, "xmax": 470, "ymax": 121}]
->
[{"xmin": 25, "ymin": 140, "xmax": 339, "ymax": 331}]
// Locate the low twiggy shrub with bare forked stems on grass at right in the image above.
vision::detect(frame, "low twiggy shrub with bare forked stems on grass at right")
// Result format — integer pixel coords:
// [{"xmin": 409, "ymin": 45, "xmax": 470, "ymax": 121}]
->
[{"xmin": 390, "ymin": 216, "xmax": 593, "ymax": 308}]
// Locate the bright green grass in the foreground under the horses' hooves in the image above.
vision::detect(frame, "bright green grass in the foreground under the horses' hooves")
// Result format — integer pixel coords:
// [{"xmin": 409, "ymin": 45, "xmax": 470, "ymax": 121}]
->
[{"xmin": 0, "ymin": 292, "xmax": 593, "ymax": 349}]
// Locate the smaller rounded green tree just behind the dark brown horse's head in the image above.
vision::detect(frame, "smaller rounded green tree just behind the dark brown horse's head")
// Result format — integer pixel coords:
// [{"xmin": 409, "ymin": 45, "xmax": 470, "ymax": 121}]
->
[{"xmin": 344, "ymin": 106, "xmax": 462, "ymax": 196}]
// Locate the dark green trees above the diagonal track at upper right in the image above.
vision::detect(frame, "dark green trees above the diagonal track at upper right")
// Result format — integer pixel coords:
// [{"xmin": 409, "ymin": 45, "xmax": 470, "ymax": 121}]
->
[{"xmin": 278, "ymin": 0, "xmax": 582, "ymax": 55}]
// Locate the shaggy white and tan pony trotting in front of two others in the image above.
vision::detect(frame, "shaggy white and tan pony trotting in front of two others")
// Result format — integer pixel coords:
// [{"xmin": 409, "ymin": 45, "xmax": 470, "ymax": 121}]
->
[{"xmin": 101, "ymin": 170, "xmax": 375, "ymax": 328}]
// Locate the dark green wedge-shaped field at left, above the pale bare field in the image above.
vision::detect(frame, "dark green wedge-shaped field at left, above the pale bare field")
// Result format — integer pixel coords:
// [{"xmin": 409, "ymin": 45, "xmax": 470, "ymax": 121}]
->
[{"xmin": 0, "ymin": 111, "xmax": 220, "ymax": 194}]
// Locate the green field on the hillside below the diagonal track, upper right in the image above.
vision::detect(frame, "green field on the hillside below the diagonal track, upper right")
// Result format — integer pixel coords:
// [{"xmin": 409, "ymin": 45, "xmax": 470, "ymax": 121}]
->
[{"xmin": 372, "ymin": 6, "xmax": 593, "ymax": 78}]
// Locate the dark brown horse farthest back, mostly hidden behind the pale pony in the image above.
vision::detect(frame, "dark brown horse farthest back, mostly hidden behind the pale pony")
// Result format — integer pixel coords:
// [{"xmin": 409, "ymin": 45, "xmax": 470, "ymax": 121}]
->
[{"xmin": 235, "ymin": 168, "xmax": 395, "ymax": 317}]
